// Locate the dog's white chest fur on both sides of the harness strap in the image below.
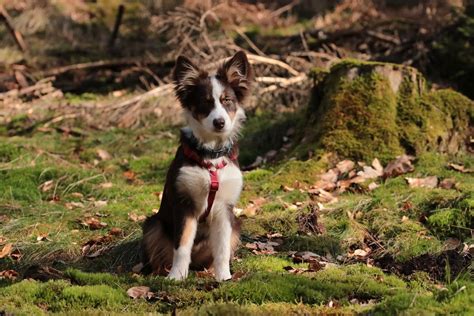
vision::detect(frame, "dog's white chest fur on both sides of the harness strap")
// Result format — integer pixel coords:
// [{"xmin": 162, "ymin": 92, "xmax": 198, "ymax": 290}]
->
[{"xmin": 176, "ymin": 161, "xmax": 243, "ymax": 213}]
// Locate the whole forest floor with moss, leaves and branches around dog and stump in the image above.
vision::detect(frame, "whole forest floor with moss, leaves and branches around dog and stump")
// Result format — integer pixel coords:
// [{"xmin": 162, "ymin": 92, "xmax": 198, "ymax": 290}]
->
[{"xmin": 0, "ymin": 0, "xmax": 474, "ymax": 316}]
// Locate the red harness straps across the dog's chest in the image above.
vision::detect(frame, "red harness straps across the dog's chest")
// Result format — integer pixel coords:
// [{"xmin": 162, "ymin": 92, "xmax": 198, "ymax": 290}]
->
[{"xmin": 182, "ymin": 144, "xmax": 237, "ymax": 222}]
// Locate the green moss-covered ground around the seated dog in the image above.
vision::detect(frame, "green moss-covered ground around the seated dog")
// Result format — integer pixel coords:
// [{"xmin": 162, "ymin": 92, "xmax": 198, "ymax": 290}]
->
[{"xmin": 0, "ymin": 97, "xmax": 474, "ymax": 315}]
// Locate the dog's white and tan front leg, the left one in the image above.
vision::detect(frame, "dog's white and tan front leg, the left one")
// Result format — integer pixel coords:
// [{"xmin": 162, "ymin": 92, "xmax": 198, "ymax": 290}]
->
[{"xmin": 168, "ymin": 216, "xmax": 197, "ymax": 280}]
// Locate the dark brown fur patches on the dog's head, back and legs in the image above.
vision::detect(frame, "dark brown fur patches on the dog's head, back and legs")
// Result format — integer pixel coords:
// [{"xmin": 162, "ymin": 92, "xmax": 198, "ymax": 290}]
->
[{"xmin": 142, "ymin": 52, "xmax": 253, "ymax": 275}]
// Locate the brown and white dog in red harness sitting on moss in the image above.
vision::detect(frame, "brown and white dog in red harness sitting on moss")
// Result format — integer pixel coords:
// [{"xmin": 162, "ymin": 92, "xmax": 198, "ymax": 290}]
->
[{"xmin": 143, "ymin": 52, "xmax": 253, "ymax": 281}]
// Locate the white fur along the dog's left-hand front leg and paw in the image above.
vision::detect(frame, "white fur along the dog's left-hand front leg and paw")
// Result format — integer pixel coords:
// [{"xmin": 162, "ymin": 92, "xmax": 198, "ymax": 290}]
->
[{"xmin": 168, "ymin": 220, "xmax": 197, "ymax": 280}]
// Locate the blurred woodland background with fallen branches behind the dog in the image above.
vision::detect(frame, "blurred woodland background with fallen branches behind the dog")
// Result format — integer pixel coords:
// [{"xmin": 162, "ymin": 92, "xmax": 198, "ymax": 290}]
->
[{"xmin": 0, "ymin": 0, "xmax": 474, "ymax": 127}]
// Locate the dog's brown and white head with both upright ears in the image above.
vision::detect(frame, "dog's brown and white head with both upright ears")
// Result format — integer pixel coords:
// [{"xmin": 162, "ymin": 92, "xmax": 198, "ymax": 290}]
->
[{"xmin": 174, "ymin": 52, "xmax": 253, "ymax": 142}]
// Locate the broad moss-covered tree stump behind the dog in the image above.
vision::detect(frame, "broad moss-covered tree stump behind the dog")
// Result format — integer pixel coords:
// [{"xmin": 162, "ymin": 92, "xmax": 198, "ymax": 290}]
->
[{"xmin": 299, "ymin": 60, "xmax": 474, "ymax": 161}]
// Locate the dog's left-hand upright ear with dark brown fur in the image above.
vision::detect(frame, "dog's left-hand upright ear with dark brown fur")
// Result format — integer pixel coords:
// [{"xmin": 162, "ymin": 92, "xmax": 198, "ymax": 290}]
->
[{"xmin": 173, "ymin": 56, "xmax": 202, "ymax": 102}]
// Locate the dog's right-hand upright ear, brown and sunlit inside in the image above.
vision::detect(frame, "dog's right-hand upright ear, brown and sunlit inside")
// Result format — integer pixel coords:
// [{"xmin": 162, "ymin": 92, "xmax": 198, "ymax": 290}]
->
[{"xmin": 218, "ymin": 51, "xmax": 253, "ymax": 102}]
